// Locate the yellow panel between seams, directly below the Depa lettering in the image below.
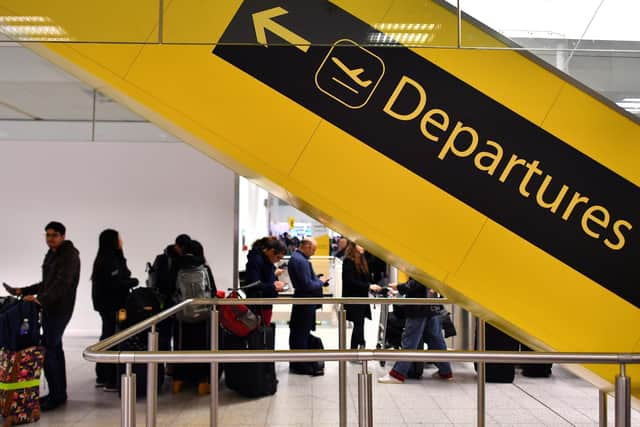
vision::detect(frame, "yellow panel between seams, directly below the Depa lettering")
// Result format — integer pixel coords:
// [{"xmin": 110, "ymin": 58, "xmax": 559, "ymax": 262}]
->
[{"xmin": 290, "ymin": 122, "xmax": 484, "ymax": 280}]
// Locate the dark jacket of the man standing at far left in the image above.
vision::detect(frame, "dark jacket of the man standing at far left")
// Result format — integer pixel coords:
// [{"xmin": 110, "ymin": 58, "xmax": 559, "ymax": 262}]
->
[{"xmin": 22, "ymin": 240, "xmax": 80, "ymax": 315}]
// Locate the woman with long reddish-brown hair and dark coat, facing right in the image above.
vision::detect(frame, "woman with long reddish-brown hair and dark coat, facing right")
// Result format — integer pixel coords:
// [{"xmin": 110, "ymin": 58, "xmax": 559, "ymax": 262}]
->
[{"xmin": 342, "ymin": 242, "xmax": 382, "ymax": 349}]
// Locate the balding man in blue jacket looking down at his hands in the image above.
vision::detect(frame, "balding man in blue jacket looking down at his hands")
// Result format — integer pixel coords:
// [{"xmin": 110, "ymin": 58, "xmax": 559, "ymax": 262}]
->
[{"xmin": 288, "ymin": 239, "xmax": 329, "ymax": 376}]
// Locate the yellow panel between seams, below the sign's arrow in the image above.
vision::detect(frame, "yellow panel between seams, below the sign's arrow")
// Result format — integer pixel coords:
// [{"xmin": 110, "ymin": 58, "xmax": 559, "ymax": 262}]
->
[{"xmin": 127, "ymin": 45, "xmax": 320, "ymax": 177}]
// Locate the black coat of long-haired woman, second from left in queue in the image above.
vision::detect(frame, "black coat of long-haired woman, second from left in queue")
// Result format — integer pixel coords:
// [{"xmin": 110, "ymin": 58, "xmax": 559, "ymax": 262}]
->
[{"xmin": 91, "ymin": 253, "xmax": 138, "ymax": 313}]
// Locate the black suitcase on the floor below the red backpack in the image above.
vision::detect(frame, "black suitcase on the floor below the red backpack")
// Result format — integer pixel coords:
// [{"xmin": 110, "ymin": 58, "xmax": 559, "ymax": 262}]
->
[{"xmin": 222, "ymin": 323, "xmax": 278, "ymax": 397}]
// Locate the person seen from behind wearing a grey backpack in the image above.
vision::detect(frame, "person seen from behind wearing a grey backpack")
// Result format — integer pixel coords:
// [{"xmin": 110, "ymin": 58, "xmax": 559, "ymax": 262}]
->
[{"xmin": 171, "ymin": 240, "xmax": 216, "ymax": 395}]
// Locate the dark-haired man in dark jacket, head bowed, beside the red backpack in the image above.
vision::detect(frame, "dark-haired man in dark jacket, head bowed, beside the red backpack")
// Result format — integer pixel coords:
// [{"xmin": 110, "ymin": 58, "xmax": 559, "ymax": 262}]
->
[{"xmin": 245, "ymin": 237, "xmax": 287, "ymax": 325}]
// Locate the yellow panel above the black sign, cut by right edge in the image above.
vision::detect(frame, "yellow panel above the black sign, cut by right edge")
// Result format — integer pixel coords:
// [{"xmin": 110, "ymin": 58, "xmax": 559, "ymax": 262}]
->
[{"xmin": 543, "ymin": 84, "xmax": 640, "ymax": 187}]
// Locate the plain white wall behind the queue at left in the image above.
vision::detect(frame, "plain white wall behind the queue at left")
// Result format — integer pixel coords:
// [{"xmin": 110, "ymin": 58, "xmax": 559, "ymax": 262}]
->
[{"xmin": 0, "ymin": 141, "xmax": 234, "ymax": 335}]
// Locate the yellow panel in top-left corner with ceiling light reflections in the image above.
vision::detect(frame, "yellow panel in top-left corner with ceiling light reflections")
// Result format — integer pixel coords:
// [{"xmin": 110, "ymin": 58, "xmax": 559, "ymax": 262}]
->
[{"xmin": 0, "ymin": 0, "xmax": 160, "ymax": 43}]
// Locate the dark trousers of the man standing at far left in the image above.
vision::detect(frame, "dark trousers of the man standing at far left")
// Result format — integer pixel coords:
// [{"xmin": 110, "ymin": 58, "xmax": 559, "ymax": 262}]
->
[{"xmin": 42, "ymin": 311, "xmax": 72, "ymax": 402}]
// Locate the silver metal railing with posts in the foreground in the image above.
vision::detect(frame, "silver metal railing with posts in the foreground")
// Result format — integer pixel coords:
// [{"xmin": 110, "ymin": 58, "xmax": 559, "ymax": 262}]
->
[{"xmin": 83, "ymin": 298, "xmax": 640, "ymax": 427}]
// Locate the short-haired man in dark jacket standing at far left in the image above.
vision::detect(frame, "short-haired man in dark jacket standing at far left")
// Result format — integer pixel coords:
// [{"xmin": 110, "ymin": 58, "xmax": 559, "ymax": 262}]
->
[{"xmin": 4, "ymin": 221, "xmax": 80, "ymax": 411}]
